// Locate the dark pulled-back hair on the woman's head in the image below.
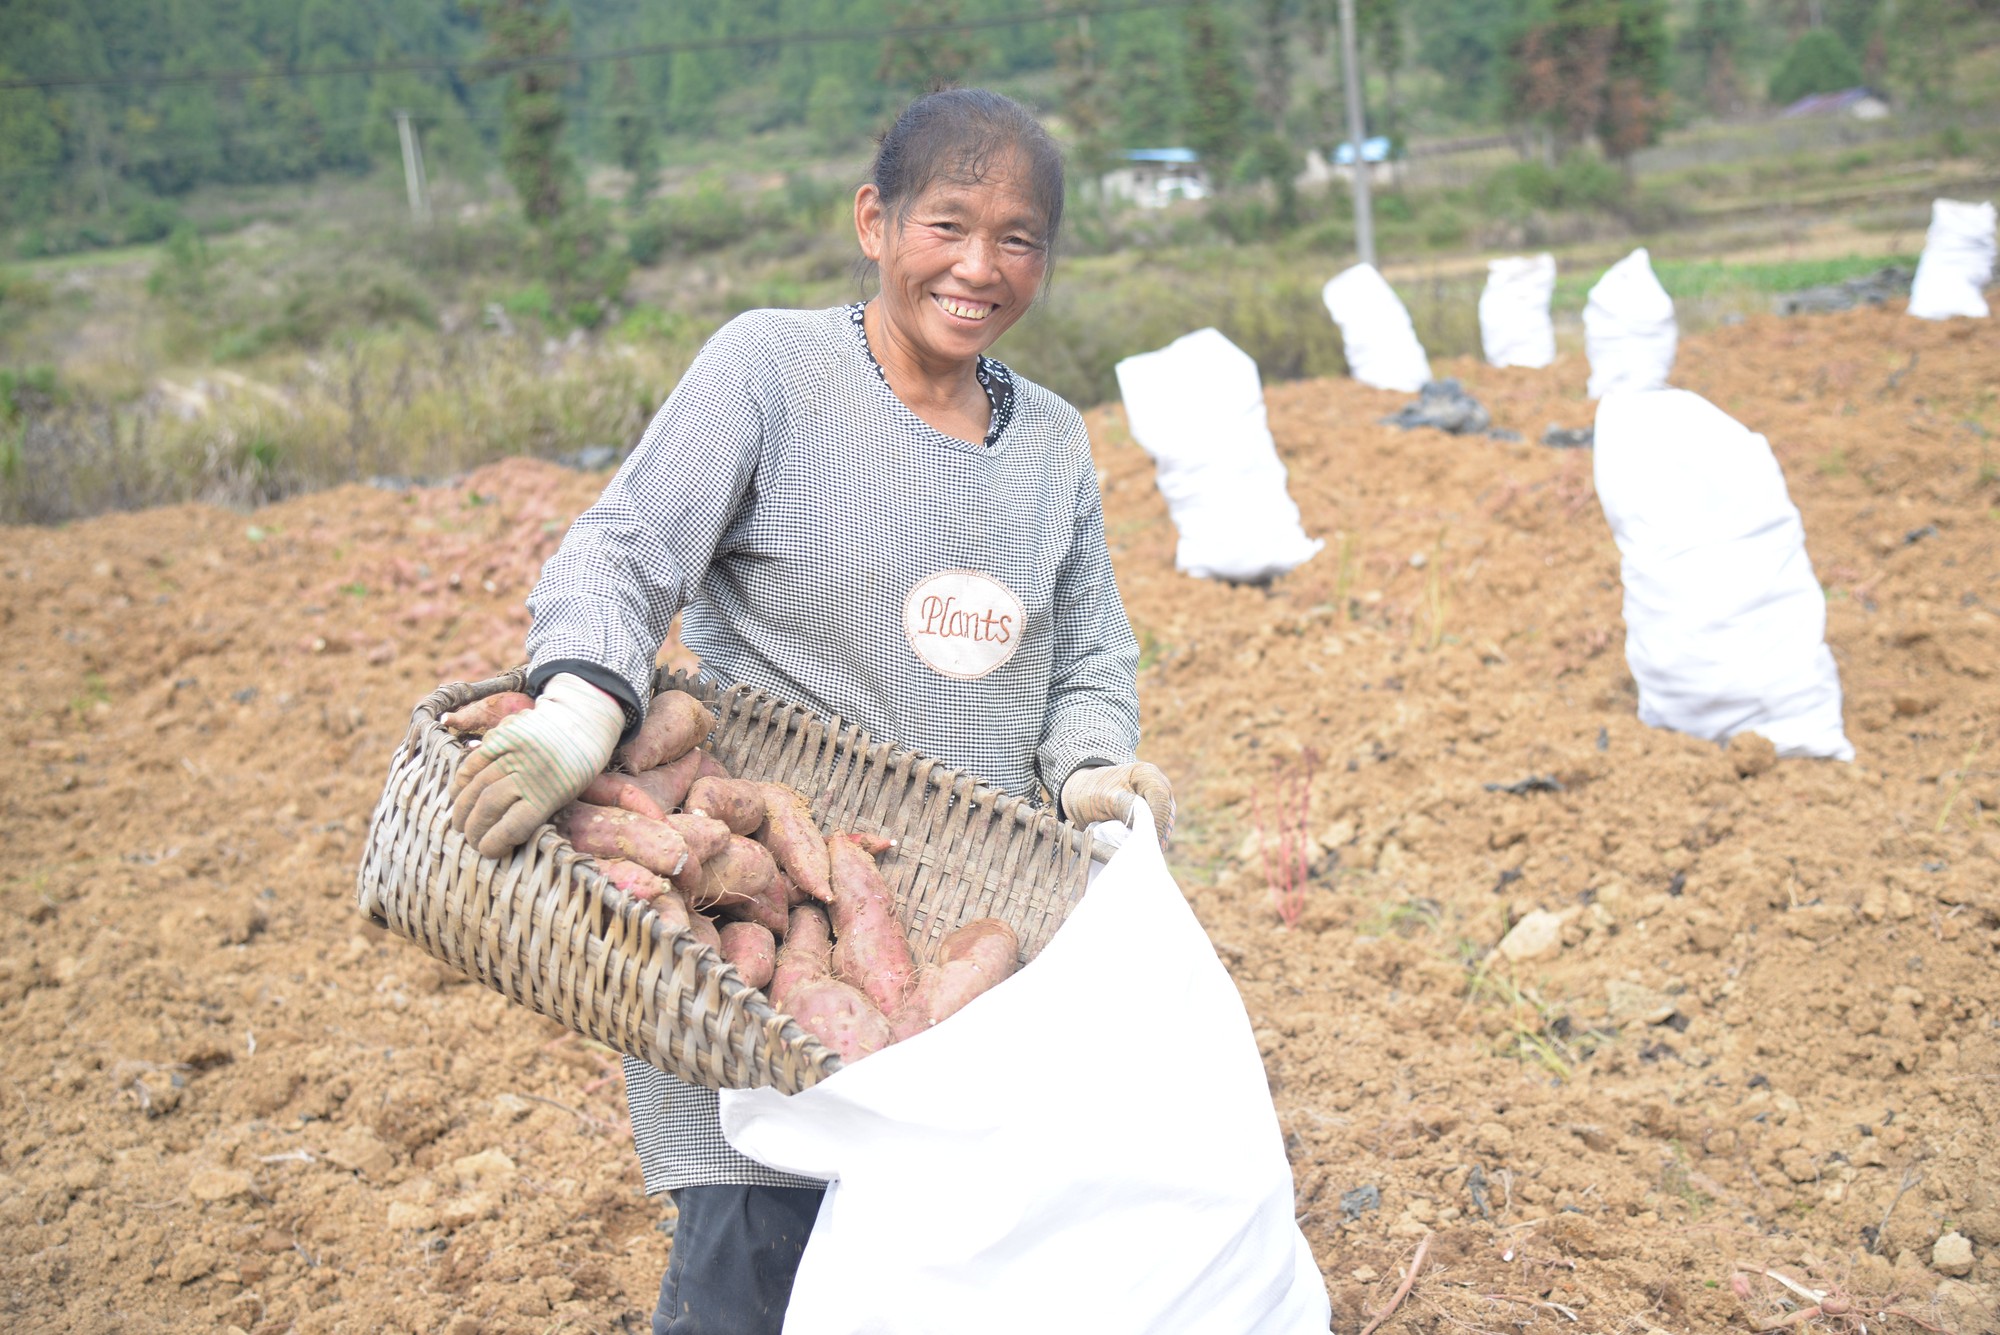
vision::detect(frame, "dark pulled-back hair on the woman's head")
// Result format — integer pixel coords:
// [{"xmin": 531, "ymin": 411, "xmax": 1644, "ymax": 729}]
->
[{"xmin": 868, "ymin": 88, "xmax": 1064, "ymax": 267}]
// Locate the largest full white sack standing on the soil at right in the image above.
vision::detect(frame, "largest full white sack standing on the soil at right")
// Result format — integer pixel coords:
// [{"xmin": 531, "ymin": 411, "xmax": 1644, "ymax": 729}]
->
[{"xmin": 1596, "ymin": 390, "xmax": 1854, "ymax": 759}]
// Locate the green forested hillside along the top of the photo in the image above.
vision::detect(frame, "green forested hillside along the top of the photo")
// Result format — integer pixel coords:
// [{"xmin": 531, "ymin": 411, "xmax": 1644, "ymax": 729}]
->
[{"xmin": 0, "ymin": 0, "xmax": 2000, "ymax": 254}]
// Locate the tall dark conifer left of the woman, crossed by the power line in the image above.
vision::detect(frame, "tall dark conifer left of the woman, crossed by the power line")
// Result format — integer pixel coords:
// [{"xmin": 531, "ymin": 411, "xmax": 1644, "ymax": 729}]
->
[{"xmin": 482, "ymin": 0, "xmax": 574, "ymax": 224}]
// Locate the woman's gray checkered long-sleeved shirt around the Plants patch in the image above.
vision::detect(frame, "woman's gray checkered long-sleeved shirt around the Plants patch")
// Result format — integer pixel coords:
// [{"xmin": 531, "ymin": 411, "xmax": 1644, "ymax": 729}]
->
[{"xmin": 528, "ymin": 308, "xmax": 1138, "ymax": 1193}]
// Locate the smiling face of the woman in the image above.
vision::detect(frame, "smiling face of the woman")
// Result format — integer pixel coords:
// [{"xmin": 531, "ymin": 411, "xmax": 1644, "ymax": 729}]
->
[{"xmin": 854, "ymin": 162, "xmax": 1048, "ymax": 370}]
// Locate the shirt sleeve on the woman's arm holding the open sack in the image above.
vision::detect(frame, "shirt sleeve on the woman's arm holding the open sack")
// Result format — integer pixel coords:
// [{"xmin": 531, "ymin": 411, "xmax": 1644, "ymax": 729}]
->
[{"xmin": 1036, "ymin": 468, "xmax": 1138, "ymax": 799}]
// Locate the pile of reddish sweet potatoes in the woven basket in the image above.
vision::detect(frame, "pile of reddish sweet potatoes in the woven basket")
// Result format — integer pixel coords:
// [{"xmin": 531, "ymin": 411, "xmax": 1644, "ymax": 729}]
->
[{"xmin": 444, "ymin": 691, "xmax": 1020, "ymax": 1061}]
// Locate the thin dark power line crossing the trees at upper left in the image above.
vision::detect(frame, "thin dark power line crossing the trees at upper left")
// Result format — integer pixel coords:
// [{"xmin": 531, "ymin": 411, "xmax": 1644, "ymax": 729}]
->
[{"xmin": 0, "ymin": 0, "xmax": 1200, "ymax": 92}]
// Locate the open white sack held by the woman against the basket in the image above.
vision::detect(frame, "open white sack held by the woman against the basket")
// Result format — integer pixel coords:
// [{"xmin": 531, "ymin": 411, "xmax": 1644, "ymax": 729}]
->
[{"xmin": 720, "ymin": 803, "xmax": 1332, "ymax": 1335}]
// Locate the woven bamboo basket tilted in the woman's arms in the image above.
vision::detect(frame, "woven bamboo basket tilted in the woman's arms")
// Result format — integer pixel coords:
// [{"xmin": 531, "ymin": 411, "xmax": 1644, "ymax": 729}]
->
[{"xmin": 358, "ymin": 668, "xmax": 1094, "ymax": 1093}]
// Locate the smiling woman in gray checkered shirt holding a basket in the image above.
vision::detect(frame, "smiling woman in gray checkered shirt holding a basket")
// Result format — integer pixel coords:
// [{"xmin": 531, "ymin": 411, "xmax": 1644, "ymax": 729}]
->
[{"xmin": 454, "ymin": 90, "xmax": 1174, "ymax": 1335}]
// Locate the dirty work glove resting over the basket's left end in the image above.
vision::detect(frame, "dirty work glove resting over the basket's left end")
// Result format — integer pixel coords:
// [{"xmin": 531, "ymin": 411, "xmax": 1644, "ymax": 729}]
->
[{"xmin": 452, "ymin": 671, "xmax": 624, "ymax": 857}]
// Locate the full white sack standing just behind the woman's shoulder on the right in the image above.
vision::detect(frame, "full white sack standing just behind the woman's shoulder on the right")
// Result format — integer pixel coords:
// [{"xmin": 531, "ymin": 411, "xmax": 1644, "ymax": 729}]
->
[{"xmin": 1118, "ymin": 330, "xmax": 1324, "ymax": 580}]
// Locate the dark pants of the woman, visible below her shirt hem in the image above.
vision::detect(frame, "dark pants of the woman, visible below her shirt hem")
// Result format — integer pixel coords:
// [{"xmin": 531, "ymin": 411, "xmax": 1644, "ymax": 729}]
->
[{"xmin": 652, "ymin": 1185, "xmax": 826, "ymax": 1335}]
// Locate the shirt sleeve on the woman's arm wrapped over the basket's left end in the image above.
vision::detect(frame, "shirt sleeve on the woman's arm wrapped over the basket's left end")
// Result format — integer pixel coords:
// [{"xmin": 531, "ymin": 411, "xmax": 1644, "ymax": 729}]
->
[{"xmin": 528, "ymin": 326, "xmax": 768, "ymax": 725}]
